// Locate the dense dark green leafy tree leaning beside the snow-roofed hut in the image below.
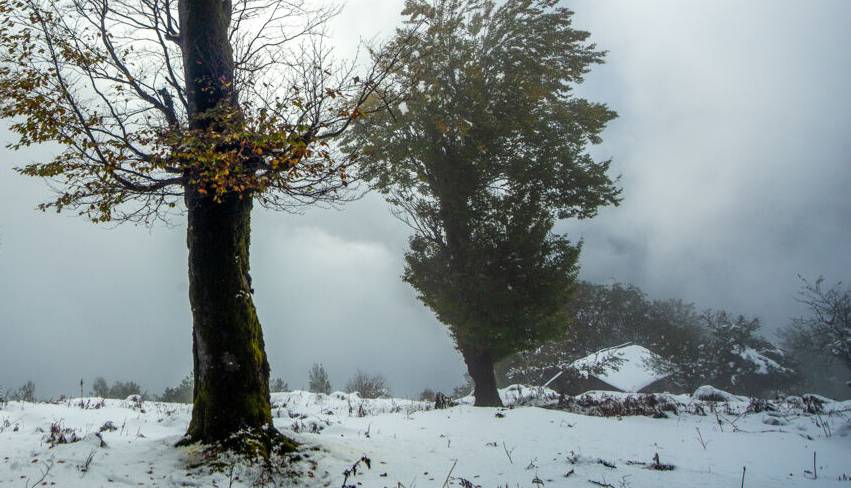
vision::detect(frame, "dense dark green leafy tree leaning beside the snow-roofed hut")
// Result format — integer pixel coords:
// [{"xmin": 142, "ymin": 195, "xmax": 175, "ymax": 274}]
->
[{"xmin": 348, "ymin": 0, "xmax": 619, "ymax": 405}]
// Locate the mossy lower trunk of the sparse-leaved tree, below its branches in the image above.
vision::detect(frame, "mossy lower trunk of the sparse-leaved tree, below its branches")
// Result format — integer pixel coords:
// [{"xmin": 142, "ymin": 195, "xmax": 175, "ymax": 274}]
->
[{"xmin": 186, "ymin": 189, "xmax": 282, "ymax": 443}]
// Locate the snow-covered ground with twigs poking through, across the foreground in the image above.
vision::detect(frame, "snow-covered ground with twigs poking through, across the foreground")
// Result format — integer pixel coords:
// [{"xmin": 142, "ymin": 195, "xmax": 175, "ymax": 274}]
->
[{"xmin": 0, "ymin": 387, "xmax": 851, "ymax": 488}]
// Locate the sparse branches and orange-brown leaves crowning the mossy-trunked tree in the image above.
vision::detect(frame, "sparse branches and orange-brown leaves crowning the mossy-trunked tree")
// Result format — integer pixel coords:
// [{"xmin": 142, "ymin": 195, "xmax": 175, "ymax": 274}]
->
[{"xmin": 0, "ymin": 0, "xmax": 412, "ymax": 222}]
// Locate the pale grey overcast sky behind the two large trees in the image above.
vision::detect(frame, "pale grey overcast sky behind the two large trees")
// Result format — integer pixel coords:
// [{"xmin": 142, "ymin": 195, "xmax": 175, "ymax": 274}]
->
[{"xmin": 0, "ymin": 0, "xmax": 851, "ymax": 396}]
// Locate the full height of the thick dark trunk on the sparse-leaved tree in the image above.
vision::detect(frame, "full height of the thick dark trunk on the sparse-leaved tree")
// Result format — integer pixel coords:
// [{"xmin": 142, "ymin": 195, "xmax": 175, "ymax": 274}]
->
[{"xmin": 178, "ymin": 0, "xmax": 293, "ymax": 450}]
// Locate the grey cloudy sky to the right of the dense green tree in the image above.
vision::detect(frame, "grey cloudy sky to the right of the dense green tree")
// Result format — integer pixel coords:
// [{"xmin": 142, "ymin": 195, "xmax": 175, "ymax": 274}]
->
[{"xmin": 565, "ymin": 1, "xmax": 851, "ymax": 328}]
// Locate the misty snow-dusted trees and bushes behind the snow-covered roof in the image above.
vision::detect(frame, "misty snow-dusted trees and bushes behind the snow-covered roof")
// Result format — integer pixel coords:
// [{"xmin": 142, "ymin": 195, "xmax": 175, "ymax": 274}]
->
[{"xmin": 498, "ymin": 280, "xmax": 851, "ymax": 398}]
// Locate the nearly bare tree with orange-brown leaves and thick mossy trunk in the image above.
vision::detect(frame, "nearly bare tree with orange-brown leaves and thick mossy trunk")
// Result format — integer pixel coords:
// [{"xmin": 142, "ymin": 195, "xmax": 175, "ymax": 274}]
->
[{"xmin": 0, "ymin": 0, "xmax": 416, "ymax": 450}]
